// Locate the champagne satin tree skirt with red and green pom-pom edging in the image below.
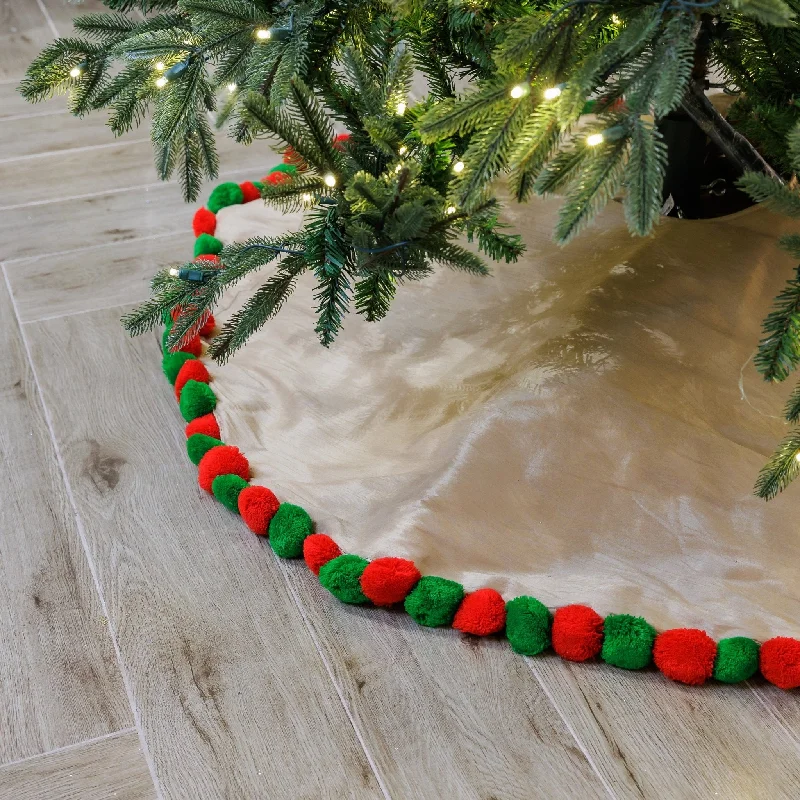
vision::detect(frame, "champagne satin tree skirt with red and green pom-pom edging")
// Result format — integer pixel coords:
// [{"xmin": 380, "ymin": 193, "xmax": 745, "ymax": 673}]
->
[{"xmin": 167, "ymin": 175, "xmax": 800, "ymax": 688}]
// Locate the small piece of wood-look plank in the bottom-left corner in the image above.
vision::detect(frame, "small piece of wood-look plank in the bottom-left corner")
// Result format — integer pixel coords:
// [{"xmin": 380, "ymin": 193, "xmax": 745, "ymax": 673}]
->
[{"xmin": 0, "ymin": 731, "xmax": 156, "ymax": 800}]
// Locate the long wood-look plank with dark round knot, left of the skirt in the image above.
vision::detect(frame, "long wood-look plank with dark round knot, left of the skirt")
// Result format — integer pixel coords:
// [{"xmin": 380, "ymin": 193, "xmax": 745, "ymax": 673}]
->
[{"xmin": 26, "ymin": 311, "xmax": 381, "ymax": 798}]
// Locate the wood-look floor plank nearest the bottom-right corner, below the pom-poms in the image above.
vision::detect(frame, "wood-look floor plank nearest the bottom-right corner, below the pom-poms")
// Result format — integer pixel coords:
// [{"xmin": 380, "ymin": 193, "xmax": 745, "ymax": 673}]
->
[{"xmin": 528, "ymin": 657, "xmax": 800, "ymax": 800}]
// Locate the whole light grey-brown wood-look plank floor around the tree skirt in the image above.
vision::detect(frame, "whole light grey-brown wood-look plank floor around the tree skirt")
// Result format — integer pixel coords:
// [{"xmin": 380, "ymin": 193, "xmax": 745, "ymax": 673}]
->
[{"xmin": 0, "ymin": 0, "xmax": 800, "ymax": 800}]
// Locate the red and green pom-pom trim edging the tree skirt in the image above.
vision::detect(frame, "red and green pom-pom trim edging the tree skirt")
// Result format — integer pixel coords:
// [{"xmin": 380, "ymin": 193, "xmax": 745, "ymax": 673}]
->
[{"xmin": 152, "ymin": 172, "xmax": 800, "ymax": 690}]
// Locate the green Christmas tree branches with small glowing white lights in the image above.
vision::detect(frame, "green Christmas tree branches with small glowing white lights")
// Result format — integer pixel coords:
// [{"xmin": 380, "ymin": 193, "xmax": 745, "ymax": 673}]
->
[{"xmin": 21, "ymin": 0, "xmax": 800, "ymax": 497}]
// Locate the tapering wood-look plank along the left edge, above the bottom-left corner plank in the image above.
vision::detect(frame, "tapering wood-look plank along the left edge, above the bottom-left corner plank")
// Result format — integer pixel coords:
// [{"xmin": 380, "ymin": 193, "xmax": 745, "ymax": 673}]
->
[{"xmin": 0, "ymin": 276, "xmax": 132, "ymax": 764}]
